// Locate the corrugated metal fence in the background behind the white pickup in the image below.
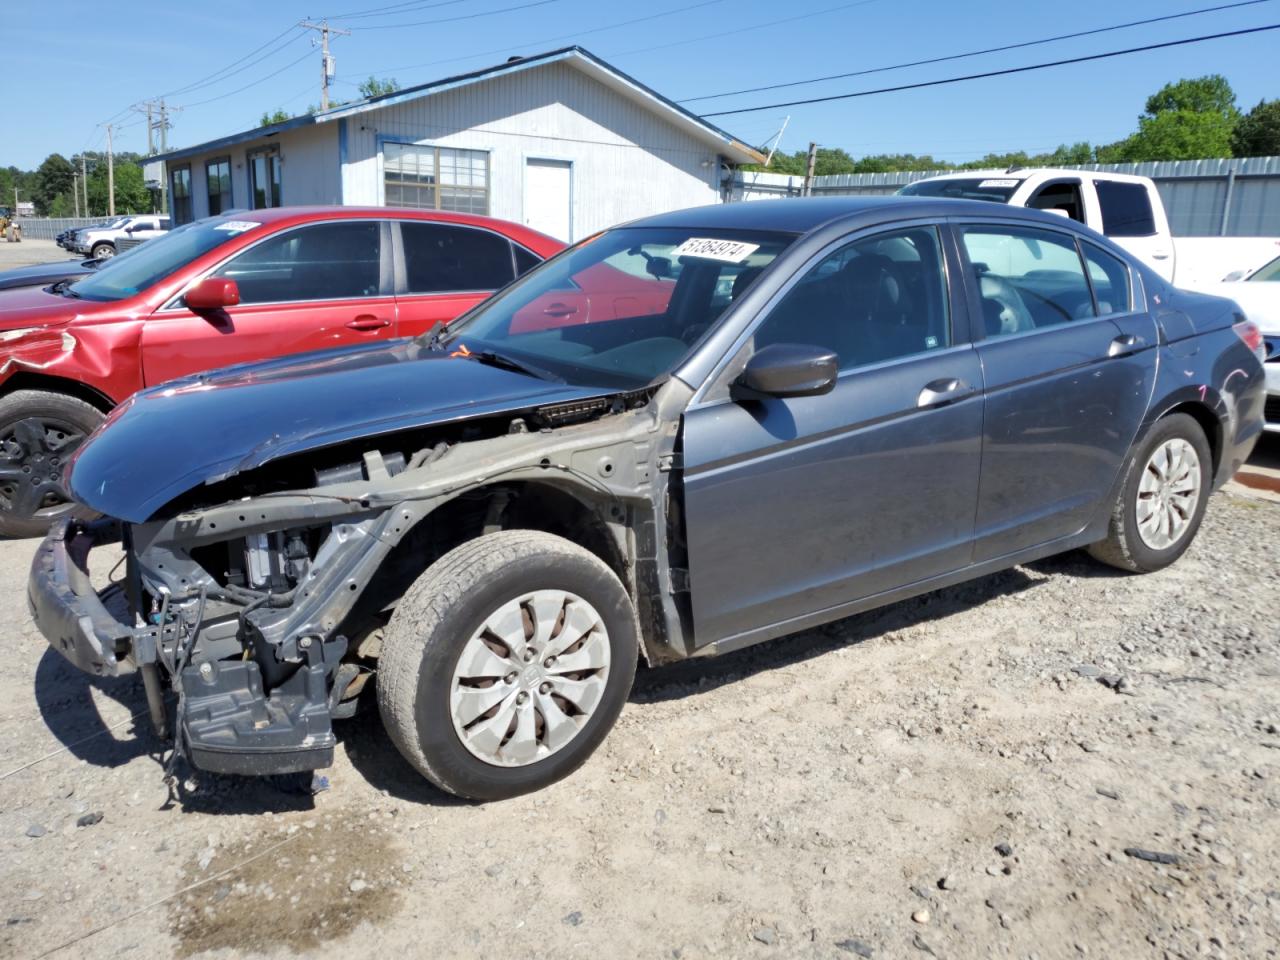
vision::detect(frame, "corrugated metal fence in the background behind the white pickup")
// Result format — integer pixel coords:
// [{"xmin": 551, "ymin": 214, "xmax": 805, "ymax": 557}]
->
[{"xmin": 733, "ymin": 156, "xmax": 1280, "ymax": 237}]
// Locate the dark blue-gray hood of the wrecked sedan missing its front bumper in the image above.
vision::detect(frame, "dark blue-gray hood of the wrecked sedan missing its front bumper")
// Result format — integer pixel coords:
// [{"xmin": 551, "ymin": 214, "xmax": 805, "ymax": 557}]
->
[{"xmin": 67, "ymin": 340, "xmax": 613, "ymax": 524}]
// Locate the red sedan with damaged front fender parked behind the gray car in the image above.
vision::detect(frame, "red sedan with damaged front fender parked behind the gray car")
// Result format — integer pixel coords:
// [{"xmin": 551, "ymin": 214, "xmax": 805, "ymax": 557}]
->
[{"xmin": 0, "ymin": 207, "xmax": 563, "ymax": 536}]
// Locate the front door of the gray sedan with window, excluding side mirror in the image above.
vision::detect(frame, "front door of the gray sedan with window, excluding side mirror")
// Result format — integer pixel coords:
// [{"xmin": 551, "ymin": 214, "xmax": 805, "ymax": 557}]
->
[{"xmin": 684, "ymin": 225, "xmax": 982, "ymax": 645}]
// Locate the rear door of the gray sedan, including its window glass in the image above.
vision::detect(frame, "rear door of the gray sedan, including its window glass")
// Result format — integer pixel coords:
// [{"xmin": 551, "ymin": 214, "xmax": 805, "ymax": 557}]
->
[{"xmin": 957, "ymin": 223, "xmax": 1156, "ymax": 562}]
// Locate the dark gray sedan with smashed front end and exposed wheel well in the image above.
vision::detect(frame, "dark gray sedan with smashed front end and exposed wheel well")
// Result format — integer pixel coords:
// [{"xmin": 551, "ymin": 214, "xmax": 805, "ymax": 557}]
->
[{"xmin": 29, "ymin": 197, "xmax": 1263, "ymax": 799}]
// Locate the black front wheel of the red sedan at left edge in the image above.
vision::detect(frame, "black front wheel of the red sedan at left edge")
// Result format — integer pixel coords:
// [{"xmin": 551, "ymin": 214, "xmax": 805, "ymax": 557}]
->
[{"xmin": 0, "ymin": 390, "xmax": 102, "ymax": 536}]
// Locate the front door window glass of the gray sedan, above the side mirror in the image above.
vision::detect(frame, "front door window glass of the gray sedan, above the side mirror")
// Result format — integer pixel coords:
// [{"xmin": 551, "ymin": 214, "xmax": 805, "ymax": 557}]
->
[{"xmin": 755, "ymin": 227, "xmax": 951, "ymax": 370}]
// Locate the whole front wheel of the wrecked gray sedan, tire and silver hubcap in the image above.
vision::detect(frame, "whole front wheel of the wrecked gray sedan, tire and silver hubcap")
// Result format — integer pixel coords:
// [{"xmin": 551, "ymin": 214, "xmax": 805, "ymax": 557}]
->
[{"xmin": 378, "ymin": 530, "xmax": 640, "ymax": 800}]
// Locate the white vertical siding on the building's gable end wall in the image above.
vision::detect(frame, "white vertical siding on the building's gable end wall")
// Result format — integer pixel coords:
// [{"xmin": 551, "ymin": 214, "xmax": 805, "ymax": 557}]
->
[{"xmin": 333, "ymin": 63, "xmax": 719, "ymax": 239}]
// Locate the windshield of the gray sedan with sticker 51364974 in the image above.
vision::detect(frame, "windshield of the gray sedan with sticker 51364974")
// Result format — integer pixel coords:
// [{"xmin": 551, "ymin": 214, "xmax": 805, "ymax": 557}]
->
[{"xmin": 438, "ymin": 227, "xmax": 794, "ymax": 389}]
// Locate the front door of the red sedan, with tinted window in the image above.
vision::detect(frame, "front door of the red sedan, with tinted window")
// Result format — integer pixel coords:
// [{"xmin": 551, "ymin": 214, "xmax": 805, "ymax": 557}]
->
[{"xmin": 142, "ymin": 219, "xmax": 396, "ymax": 385}]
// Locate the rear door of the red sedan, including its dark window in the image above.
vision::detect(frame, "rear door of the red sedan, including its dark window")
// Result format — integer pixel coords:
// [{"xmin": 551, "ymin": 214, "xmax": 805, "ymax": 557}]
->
[{"xmin": 396, "ymin": 220, "xmax": 527, "ymax": 337}]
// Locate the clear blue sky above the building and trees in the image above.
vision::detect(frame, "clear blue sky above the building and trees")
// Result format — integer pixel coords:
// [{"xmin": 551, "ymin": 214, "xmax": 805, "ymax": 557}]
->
[{"xmin": 0, "ymin": 0, "xmax": 1280, "ymax": 168}]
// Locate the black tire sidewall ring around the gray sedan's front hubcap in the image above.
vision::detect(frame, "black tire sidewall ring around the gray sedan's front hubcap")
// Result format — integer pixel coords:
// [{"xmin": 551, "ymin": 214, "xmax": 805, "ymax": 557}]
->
[{"xmin": 413, "ymin": 553, "xmax": 639, "ymax": 800}]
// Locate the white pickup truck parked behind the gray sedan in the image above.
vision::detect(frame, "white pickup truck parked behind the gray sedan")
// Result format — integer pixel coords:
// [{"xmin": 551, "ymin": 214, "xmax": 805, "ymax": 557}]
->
[{"xmin": 899, "ymin": 169, "xmax": 1280, "ymax": 433}]
